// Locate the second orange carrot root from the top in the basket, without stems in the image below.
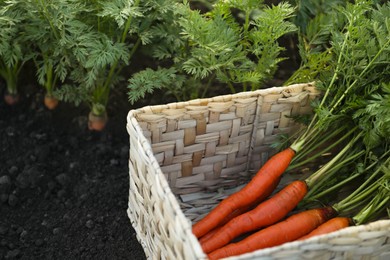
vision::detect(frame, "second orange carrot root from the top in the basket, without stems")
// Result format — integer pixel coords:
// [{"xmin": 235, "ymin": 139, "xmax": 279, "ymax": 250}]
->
[{"xmin": 201, "ymin": 180, "xmax": 308, "ymax": 254}]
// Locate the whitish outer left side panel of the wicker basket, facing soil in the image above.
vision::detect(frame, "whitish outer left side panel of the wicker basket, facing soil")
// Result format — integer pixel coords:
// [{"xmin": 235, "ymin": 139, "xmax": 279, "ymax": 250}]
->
[{"xmin": 127, "ymin": 114, "xmax": 205, "ymax": 259}]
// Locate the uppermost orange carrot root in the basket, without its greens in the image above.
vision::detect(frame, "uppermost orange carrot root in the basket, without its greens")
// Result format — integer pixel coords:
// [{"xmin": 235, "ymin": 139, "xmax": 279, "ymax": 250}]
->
[{"xmin": 192, "ymin": 148, "xmax": 295, "ymax": 238}]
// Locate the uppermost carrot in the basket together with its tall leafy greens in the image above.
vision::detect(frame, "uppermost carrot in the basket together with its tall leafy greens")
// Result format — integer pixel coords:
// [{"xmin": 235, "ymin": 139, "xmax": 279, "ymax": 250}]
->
[{"xmin": 193, "ymin": 1, "xmax": 390, "ymax": 254}]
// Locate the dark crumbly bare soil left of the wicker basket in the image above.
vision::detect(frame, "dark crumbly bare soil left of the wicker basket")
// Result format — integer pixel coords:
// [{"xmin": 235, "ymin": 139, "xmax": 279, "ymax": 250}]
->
[{"xmin": 0, "ymin": 86, "xmax": 145, "ymax": 259}]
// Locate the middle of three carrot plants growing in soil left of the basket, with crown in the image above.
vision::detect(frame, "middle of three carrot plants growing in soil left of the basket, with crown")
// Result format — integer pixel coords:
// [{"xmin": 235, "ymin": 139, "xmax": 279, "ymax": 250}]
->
[{"xmin": 19, "ymin": 0, "xmax": 87, "ymax": 110}]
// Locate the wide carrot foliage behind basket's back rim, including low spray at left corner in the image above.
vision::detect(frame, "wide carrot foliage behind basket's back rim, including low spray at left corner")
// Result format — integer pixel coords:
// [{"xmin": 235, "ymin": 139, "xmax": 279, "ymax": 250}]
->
[{"xmin": 128, "ymin": 0, "xmax": 297, "ymax": 102}]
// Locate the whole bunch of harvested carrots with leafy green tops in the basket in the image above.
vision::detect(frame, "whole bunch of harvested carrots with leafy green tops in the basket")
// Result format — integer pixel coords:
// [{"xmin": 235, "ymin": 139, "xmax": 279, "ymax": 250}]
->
[{"xmin": 192, "ymin": 2, "xmax": 390, "ymax": 259}]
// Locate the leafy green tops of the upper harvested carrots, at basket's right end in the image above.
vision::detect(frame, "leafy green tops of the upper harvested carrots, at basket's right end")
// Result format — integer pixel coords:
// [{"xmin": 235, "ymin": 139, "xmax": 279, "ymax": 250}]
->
[{"xmin": 284, "ymin": 0, "xmax": 390, "ymax": 199}]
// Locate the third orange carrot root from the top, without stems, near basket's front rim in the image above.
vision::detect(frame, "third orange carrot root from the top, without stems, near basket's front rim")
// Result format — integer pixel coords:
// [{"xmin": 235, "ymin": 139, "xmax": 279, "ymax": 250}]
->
[{"xmin": 208, "ymin": 207, "xmax": 336, "ymax": 260}]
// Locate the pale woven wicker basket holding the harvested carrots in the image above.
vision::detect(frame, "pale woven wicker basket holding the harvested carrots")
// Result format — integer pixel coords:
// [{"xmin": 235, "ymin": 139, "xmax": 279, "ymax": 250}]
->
[{"xmin": 127, "ymin": 84, "xmax": 390, "ymax": 259}]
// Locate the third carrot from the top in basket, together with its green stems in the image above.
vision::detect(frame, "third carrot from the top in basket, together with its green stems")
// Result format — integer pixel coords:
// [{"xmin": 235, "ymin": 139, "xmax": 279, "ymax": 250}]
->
[{"xmin": 209, "ymin": 157, "xmax": 390, "ymax": 259}]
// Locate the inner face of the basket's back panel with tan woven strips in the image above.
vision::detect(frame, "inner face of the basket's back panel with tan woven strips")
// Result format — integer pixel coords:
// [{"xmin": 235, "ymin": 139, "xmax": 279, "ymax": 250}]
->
[{"xmin": 131, "ymin": 84, "xmax": 319, "ymax": 221}]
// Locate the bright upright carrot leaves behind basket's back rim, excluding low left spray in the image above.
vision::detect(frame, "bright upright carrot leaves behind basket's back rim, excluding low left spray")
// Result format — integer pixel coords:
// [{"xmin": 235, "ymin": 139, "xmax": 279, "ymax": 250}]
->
[{"xmin": 180, "ymin": 1, "xmax": 295, "ymax": 91}]
